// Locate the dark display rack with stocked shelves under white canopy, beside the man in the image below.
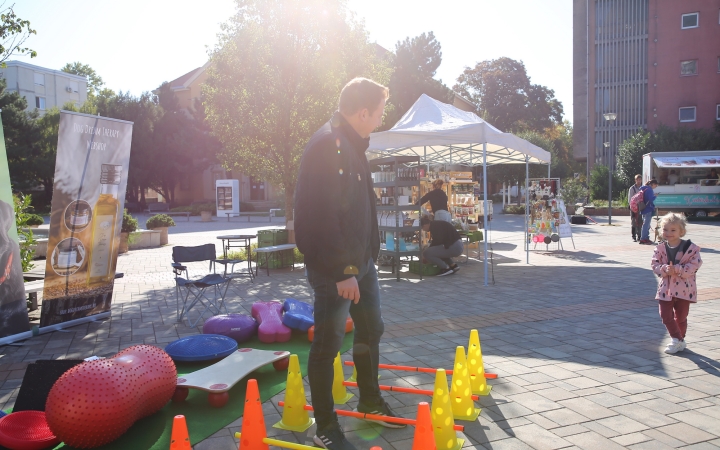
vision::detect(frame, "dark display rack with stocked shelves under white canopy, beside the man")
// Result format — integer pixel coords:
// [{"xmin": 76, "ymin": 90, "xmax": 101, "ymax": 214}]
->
[{"xmin": 369, "ymin": 156, "xmax": 423, "ymax": 281}]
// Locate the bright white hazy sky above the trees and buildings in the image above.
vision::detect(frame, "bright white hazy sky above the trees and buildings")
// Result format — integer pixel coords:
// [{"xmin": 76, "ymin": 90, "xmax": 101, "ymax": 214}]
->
[{"xmin": 8, "ymin": 0, "xmax": 572, "ymax": 120}]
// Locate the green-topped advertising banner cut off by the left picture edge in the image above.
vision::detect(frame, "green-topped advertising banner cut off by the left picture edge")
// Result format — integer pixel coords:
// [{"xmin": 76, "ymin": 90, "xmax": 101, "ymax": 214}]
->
[{"xmin": 0, "ymin": 116, "xmax": 30, "ymax": 338}]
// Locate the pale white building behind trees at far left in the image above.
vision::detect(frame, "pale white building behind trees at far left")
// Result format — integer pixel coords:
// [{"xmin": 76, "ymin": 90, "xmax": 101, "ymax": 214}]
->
[{"xmin": 0, "ymin": 61, "xmax": 87, "ymax": 114}]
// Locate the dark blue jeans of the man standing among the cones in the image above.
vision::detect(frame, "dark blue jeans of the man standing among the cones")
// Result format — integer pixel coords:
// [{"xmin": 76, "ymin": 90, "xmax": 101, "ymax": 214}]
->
[{"xmin": 307, "ymin": 259, "xmax": 385, "ymax": 430}]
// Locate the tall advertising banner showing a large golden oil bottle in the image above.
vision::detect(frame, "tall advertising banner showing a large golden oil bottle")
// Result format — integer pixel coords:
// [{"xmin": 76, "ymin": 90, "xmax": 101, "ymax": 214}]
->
[{"xmin": 40, "ymin": 111, "xmax": 133, "ymax": 327}]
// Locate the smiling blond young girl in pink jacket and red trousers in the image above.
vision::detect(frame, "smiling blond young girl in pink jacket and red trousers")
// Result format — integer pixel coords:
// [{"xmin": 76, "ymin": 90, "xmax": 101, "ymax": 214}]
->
[{"xmin": 651, "ymin": 212, "xmax": 702, "ymax": 354}]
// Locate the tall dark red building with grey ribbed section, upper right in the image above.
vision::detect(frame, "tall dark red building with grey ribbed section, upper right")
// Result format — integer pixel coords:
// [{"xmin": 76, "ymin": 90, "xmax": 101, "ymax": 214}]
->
[{"xmin": 573, "ymin": 0, "xmax": 720, "ymax": 170}]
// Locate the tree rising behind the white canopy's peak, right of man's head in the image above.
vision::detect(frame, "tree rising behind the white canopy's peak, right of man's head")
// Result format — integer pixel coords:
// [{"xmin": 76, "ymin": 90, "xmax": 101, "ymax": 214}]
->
[{"xmin": 385, "ymin": 31, "xmax": 454, "ymax": 128}]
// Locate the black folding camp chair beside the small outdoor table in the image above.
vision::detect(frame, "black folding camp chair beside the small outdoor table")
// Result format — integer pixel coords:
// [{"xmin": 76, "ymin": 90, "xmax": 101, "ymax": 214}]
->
[{"xmin": 172, "ymin": 244, "xmax": 231, "ymax": 327}]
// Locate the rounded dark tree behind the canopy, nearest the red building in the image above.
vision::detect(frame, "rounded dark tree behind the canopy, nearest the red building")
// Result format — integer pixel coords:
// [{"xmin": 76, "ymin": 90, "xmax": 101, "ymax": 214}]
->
[{"xmin": 453, "ymin": 57, "xmax": 563, "ymax": 132}]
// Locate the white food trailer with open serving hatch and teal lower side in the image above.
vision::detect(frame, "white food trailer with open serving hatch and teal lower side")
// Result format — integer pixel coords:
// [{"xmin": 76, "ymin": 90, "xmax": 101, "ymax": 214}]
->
[{"xmin": 642, "ymin": 150, "xmax": 720, "ymax": 217}]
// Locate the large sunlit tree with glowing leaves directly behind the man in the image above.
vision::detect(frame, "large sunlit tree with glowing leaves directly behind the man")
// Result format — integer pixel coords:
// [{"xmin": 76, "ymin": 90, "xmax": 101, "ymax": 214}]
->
[{"xmin": 203, "ymin": 0, "xmax": 388, "ymax": 220}]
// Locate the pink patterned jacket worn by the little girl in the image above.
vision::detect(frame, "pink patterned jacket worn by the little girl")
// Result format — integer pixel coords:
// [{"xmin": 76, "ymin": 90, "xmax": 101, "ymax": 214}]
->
[{"xmin": 651, "ymin": 241, "xmax": 702, "ymax": 302}]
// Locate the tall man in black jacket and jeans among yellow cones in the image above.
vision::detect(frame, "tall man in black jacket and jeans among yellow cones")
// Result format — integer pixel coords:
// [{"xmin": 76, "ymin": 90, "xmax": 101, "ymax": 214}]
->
[{"xmin": 295, "ymin": 78, "xmax": 404, "ymax": 450}]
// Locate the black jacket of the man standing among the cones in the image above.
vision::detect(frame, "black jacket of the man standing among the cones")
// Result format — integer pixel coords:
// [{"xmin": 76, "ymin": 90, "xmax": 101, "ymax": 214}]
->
[{"xmin": 295, "ymin": 112, "xmax": 380, "ymax": 282}]
